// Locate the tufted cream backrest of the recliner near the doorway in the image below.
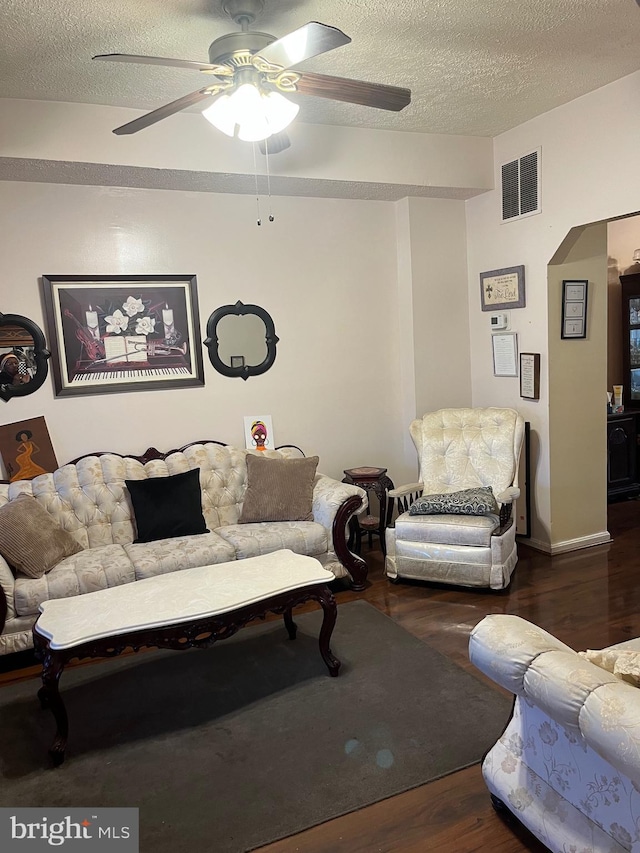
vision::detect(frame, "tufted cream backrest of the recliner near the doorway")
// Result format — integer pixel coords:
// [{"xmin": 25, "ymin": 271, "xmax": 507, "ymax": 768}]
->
[{"xmin": 409, "ymin": 408, "xmax": 524, "ymax": 496}]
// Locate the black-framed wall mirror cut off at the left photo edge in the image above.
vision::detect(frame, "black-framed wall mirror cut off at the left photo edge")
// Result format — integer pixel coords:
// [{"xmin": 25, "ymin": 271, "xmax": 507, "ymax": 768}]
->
[{"xmin": 0, "ymin": 313, "xmax": 51, "ymax": 402}]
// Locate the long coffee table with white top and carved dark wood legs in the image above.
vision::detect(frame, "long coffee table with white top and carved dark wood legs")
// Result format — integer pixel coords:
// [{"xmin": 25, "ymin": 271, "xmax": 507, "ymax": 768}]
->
[{"xmin": 33, "ymin": 550, "xmax": 340, "ymax": 765}]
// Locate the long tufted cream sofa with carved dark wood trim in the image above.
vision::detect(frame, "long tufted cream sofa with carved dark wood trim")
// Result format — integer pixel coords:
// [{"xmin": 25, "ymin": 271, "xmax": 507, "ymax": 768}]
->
[{"xmin": 0, "ymin": 441, "xmax": 367, "ymax": 654}]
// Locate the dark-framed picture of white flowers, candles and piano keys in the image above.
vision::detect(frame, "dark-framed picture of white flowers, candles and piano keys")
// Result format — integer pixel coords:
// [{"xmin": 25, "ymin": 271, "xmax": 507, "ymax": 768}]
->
[{"xmin": 42, "ymin": 275, "xmax": 204, "ymax": 397}]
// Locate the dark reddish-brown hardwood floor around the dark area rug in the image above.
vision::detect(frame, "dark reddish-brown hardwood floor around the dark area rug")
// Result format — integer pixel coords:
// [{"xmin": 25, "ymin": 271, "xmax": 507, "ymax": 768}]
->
[{"xmin": 0, "ymin": 500, "xmax": 640, "ymax": 853}]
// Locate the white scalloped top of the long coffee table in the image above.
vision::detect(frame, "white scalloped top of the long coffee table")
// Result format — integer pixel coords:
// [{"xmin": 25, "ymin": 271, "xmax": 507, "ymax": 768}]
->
[{"xmin": 36, "ymin": 550, "xmax": 334, "ymax": 649}]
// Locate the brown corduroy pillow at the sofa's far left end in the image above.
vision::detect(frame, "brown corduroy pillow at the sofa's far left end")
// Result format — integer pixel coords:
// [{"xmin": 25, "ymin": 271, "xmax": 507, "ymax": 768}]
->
[{"xmin": 0, "ymin": 495, "xmax": 82, "ymax": 578}]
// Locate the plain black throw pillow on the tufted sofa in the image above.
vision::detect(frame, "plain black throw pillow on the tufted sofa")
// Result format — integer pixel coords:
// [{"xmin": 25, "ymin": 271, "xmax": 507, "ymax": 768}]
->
[{"xmin": 125, "ymin": 468, "xmax": 209, "ymax": 542}]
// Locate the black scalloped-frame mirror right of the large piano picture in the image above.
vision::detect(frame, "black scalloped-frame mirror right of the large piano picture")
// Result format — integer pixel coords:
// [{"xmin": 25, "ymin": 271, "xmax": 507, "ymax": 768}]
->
[{"xmin": 204, "ymin": 302, "xmax": 279, "ymax": 379}]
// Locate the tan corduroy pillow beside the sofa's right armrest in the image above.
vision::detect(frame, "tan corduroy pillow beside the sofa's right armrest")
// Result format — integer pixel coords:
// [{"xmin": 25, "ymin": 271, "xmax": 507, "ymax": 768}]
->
[{"xmin": 238, "ymin": 453, "xmax": 318, "ymax": 524}]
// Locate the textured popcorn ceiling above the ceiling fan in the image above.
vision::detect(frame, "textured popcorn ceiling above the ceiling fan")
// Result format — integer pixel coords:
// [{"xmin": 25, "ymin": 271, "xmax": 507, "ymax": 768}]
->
[{"xmin": 0, "ymin": 0, "xmax": 640, "ymax": 136}]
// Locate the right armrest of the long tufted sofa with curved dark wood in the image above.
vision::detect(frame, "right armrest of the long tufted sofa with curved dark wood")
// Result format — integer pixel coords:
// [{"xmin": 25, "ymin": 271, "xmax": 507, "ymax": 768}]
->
[{"xmin": 312, "ymin": 474, "xmax": 368, "ymax": 590}]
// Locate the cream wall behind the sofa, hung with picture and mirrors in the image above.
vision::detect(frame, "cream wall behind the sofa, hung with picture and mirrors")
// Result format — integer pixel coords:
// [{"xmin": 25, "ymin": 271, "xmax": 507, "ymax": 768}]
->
[{"xmin": 0, "ymin": 182, "xmax": 416, "ymax": 478}]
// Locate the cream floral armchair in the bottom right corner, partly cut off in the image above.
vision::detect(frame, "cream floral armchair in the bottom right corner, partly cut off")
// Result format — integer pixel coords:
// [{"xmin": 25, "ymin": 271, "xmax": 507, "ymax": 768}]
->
[{"xmin": 469, "ymin": 615, "xmax": 640, "ymax": 853}]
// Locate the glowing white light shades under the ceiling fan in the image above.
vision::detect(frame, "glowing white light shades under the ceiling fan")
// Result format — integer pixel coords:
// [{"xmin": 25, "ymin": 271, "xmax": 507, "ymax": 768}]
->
[{"xmin": 202, "ymin": 83, "xmax": 299, "ymax": 142}]
